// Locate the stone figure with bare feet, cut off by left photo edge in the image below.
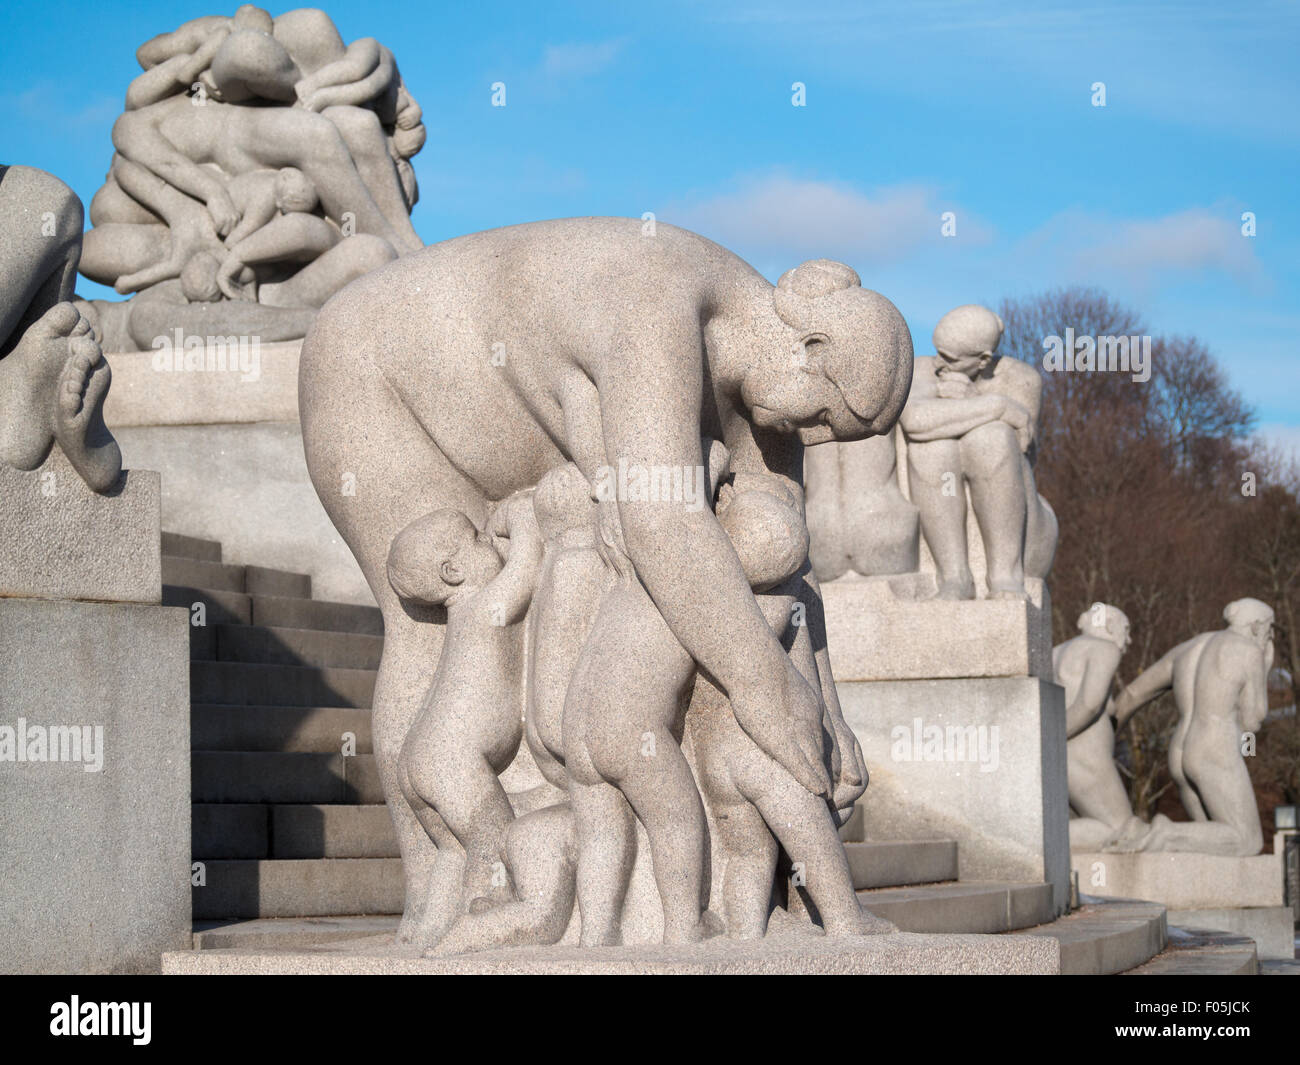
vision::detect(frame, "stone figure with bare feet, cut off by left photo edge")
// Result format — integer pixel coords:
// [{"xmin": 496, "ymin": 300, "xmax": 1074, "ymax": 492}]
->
[{"xmin": 0, "ymin": 166, "xmax": 122, "ymax": 492}]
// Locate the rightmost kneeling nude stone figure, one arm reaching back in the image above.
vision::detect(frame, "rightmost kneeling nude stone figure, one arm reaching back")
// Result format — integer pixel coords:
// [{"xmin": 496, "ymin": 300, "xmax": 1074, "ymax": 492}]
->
[{"xmin": 1113, "ymin": 598, "xmax": 1273, "ymax": 857}]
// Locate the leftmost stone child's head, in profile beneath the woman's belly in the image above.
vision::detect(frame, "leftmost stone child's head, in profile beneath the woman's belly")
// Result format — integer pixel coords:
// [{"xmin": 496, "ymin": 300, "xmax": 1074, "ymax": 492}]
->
[{"xmin": 389, "ymin": 508, "xmax": 502, "ymax": 606}]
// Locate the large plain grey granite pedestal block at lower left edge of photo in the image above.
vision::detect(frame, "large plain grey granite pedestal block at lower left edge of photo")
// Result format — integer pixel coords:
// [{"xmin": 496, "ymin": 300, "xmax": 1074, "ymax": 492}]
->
[{"xmin": 0, "ymin": 600, "xmax": 191, "ymax": 974}]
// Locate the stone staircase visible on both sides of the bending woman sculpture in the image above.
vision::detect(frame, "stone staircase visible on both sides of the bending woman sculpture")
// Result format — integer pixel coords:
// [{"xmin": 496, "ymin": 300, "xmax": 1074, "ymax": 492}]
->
[{"xmin": 163, "ymin": 533, "xmax": 1257, "ymax": 974}]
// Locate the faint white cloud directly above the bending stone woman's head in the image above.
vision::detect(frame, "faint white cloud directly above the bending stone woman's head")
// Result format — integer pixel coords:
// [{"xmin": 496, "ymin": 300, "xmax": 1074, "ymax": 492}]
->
[{"xmin": 659, "ymin": 174, "xmax": 991, "ymax": 267}]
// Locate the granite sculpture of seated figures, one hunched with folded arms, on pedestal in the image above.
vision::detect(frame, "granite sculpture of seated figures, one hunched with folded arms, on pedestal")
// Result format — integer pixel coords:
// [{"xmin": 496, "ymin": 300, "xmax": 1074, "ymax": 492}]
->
[{"xmin": 806, "ymin": 304, "xmax": 1058, "ymax": 601}]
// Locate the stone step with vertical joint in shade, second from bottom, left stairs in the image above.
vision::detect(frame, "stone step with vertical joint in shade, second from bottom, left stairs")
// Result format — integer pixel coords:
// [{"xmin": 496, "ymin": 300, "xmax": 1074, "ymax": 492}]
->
[{"xmin": 191, "ymin": 802, "xmax": 399, "ymax": 861}]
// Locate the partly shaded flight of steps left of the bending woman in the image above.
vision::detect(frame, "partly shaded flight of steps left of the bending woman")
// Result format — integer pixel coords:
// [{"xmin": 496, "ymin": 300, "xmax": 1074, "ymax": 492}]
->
[{"xmin": 163, "ymin": 533, "xmax": 402, "ymax": 921}]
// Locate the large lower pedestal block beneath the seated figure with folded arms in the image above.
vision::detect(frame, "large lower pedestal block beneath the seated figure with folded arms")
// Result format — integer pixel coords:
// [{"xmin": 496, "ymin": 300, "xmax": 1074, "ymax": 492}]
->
[{"xmin": 831, "ymin": 676, "xmax": 1070, "ymax": 914}]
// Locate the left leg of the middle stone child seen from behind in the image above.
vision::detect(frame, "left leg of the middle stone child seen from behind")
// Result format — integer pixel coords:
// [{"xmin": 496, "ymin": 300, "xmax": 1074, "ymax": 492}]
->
[{"xmin": 569, "ymin": 779, "xmax": 637, "ymax": 947}]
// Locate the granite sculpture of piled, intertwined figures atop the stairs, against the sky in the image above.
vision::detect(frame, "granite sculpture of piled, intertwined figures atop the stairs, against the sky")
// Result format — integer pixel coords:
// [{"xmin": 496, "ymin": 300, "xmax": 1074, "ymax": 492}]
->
[{"xmin": 81, "ymin": 4, "xmax": 425, "ymax": 350}]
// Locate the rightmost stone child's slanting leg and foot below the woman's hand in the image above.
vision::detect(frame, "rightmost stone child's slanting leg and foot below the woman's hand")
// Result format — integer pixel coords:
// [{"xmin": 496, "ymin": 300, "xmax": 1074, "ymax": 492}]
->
[{"xmin": 740, "ymin": 749, "xmax": 894, "ymax": 935}]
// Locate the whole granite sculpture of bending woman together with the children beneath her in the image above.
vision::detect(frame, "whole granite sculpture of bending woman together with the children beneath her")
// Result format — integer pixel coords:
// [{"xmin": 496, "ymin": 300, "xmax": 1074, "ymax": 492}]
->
[{"xmin": 299, "ymin": 218, "xmax": 911, "ymax": 949}]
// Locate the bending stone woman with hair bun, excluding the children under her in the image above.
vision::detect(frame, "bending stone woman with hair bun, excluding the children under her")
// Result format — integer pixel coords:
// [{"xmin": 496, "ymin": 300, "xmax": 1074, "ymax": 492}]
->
[{"xmin": 299, "ymin": 218, "xmax": 911, "ymax": 934}]
